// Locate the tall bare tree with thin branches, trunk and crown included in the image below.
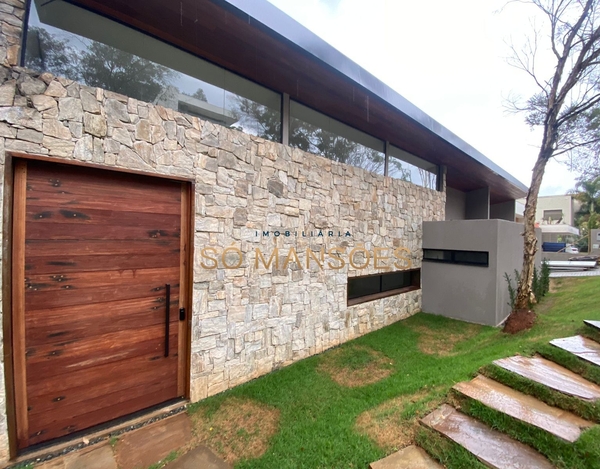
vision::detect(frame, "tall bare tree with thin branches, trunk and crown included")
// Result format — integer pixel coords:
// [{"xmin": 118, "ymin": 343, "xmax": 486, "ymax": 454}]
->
[{"xmin": 511, "ymin": 0, "xmax": 600, "ymax": 309}]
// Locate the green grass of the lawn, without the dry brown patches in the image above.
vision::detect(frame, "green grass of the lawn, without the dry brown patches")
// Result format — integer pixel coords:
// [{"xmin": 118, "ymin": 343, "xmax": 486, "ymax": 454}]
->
[{"xmin": 189, "ymin": 278, "xmax": 600, "ymax": 469}]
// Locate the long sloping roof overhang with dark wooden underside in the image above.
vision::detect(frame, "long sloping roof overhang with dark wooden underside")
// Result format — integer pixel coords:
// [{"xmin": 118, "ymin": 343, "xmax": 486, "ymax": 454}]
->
[{"xmin": 66, "ymin": 0, "xmax": 527, "ymax": 204}]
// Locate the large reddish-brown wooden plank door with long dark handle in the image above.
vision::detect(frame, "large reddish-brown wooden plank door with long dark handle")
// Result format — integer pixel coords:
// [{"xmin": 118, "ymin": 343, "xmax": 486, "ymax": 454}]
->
[{"xmin": 13, "ymin": 161, "xmax": 187, "ymax": 449}]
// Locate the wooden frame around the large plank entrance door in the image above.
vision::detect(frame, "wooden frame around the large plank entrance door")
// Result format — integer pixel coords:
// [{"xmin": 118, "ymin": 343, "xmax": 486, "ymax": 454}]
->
[{"xmin": 2, "ymin": 151, "xmax": 195, "ymax": 459}]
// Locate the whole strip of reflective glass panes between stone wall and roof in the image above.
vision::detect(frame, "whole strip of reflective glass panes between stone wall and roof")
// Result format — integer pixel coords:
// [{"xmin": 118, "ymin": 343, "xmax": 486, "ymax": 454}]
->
[{"xmin": 25, "ymin": 0, "xmax": 438, "ymax": 189}]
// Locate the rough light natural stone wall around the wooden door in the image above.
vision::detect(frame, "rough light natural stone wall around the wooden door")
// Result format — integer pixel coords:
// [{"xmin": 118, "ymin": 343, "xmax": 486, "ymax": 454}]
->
[{"xmin": 0, "ymin": 0, "xmax": 445, "ymax": 461}]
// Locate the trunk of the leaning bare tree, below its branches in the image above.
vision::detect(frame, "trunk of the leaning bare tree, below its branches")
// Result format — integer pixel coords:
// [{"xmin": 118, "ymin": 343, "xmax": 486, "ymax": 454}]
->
[{"xmin": 514, "ymin": 149, "xmax": 551, "ymax": 311}]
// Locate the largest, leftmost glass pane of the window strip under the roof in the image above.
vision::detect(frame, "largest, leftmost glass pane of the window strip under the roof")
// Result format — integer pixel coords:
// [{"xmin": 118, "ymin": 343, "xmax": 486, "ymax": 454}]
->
[{"xmin": 25, "ymin": 1, "xmax": 281, "ymax": 141}]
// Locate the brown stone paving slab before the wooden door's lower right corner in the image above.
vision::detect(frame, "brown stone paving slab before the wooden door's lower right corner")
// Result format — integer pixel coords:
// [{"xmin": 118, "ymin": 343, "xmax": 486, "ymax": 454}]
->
[{"xmin": 115, "ymin": 413, "xmax": 192, "ymax": 469}]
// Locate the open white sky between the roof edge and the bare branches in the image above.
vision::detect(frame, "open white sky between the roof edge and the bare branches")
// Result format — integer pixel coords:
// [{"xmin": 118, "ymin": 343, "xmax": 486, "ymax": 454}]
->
[{"xmin": 269, "ymin": 0, "xmax": 577, "ymax": 195}]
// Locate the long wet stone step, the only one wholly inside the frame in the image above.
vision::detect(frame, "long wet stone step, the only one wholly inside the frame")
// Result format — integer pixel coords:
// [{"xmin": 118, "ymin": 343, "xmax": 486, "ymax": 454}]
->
[{"xmin": 454, "ymin": 375, "xmax": 593, "ymax": 443}]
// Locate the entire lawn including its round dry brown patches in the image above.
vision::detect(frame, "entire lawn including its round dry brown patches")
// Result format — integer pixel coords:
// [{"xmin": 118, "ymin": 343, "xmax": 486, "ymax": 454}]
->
[{"xmin": 189, "ymin": 277, "xmax": 600, "ymax": 469}]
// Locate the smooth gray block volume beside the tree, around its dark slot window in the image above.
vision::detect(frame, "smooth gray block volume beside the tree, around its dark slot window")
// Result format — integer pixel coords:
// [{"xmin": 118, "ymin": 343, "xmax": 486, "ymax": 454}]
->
[{"xmin": 421, "ymin": 220, "xmax": 523, "ymax": 326}]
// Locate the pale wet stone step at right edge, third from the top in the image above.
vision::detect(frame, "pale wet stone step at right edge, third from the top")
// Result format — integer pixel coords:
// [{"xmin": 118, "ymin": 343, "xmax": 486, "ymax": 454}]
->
[{"xmin": 494, "ymin": 355, "xmax": 600, "ymax": 401}]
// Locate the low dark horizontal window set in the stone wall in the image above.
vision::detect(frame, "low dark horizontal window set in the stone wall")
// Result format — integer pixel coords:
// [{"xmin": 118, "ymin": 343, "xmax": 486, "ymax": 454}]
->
[{"xmin": 348, "ymin": 269, "xmax": 421, "ymax": 306}]
